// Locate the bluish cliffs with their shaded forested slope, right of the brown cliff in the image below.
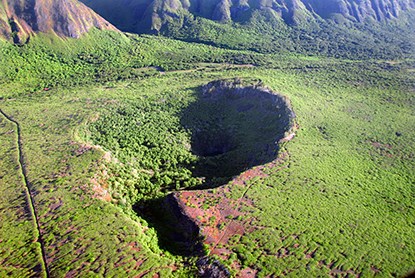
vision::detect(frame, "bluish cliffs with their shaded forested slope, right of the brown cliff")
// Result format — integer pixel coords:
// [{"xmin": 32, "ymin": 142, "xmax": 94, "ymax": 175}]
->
[{"xmin": 79, "ymin": 0, "xmax": 415, "ymax": 59}]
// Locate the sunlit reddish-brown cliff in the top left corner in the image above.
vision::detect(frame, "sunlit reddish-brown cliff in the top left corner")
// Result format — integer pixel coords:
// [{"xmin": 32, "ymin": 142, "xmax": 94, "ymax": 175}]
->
[{"xmin": 0, "ymin": 0, "xmax": 116, "ymax": 43}]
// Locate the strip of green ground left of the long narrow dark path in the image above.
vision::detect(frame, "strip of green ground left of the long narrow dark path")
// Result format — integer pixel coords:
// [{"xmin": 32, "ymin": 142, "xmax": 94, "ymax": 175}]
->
[{"xmin": 0, "ymin": 110, "xmax": 43, "ymax": 277}]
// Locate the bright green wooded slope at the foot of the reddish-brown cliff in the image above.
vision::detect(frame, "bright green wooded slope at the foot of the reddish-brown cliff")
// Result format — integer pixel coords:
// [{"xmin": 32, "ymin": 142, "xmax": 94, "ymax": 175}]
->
[{"xmin": 0, "ymin": 30, "xmax": 278, "ymax": 96}]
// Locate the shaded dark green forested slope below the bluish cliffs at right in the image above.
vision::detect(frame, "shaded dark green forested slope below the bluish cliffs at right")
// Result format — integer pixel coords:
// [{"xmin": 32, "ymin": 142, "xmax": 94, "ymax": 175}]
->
[{"xmin": 161, "ymin": 11, "xmax": 415, "ymax": 59}]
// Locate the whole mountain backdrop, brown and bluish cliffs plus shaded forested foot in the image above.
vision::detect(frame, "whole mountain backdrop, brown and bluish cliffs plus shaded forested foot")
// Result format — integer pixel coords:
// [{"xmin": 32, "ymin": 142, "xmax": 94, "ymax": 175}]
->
[{"xmin": 0, "ymin": 0, "xmax": 415, "ymax": 59}]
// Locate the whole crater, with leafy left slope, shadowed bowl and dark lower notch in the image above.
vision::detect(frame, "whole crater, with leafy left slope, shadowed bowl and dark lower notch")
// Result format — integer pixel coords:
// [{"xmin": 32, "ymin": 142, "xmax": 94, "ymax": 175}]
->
[{"xmin": 86, "ymin": 79, "xmax": 295, "ymax": 256}]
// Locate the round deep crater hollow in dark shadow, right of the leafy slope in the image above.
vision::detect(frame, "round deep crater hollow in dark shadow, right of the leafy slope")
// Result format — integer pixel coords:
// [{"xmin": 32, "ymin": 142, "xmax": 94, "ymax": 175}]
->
[{"xmin": 181, "ymin": 79, "xmax": 295, "ymax": 189}]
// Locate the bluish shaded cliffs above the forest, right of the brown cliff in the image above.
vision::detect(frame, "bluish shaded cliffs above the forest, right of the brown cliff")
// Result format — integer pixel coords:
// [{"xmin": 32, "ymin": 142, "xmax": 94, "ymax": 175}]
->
[{"xmin": 81, "ymin": 0, "xmax": 415, "ymax": 31}]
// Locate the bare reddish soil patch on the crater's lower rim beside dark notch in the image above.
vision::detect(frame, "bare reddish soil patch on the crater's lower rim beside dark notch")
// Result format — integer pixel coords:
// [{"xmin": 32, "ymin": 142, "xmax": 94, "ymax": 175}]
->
[{"xmin": 175, "ymin": 149, "xmax": 288, "ymax": 272}]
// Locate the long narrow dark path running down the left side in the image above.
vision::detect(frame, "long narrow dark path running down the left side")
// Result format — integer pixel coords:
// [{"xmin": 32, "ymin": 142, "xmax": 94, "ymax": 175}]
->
[{"xmin": 0, "ymin": 109, "xmax": 50, "ymax": 278}]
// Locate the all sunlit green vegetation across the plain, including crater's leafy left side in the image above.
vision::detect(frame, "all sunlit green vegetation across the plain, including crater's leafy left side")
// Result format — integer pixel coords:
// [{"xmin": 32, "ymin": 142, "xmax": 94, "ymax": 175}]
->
[{"xmin": 0, "ymin": 27, "xmax": 415, "ymax": 277}]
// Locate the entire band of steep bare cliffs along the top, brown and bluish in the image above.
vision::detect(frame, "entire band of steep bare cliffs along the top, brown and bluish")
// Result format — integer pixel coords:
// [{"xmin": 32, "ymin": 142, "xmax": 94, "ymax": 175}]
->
[{"xmin": 0, "ymin": 0, "xmax": 415, "ymax": 43}]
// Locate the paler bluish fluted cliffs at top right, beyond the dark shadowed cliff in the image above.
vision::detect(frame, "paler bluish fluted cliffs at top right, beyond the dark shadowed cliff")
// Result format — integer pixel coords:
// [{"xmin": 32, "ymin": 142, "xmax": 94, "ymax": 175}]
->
[{"xmin": 160, "ymin": 0, "xmax": 415, "ymax": 23}]
